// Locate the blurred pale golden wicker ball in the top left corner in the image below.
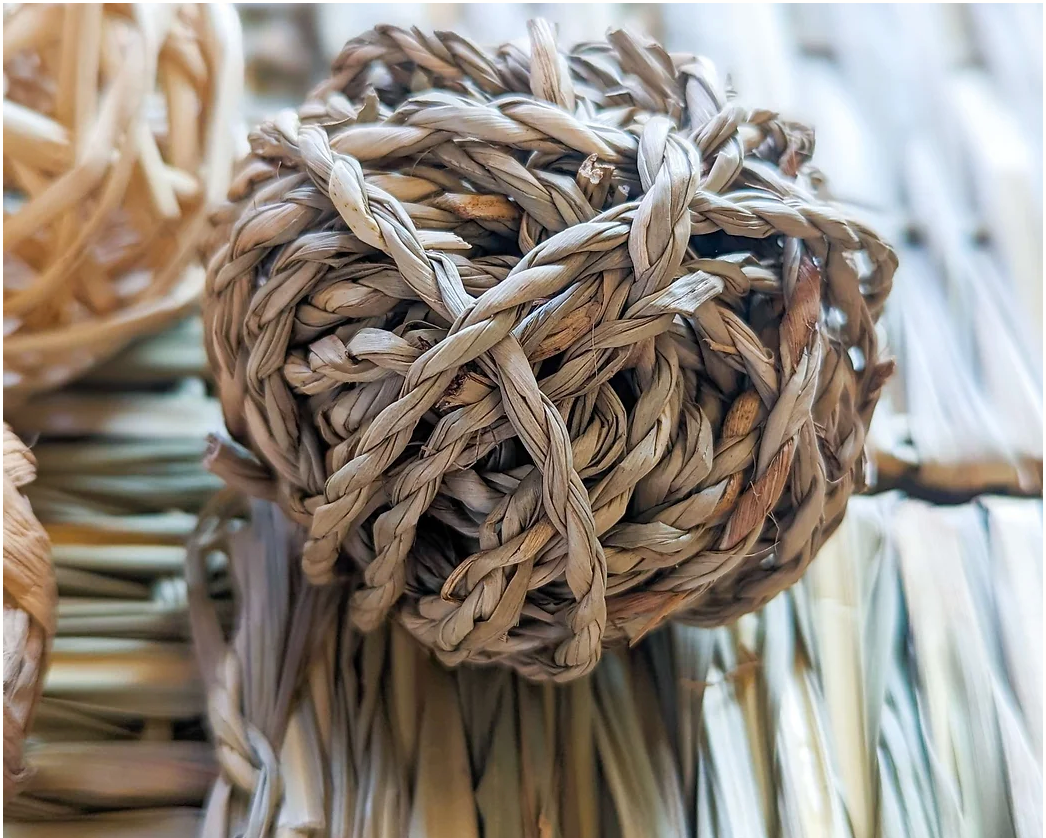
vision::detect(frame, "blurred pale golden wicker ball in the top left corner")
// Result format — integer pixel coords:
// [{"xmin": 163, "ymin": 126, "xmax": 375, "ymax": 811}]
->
[{"xmin": 3, "ymin": 3, "xmax": 246, "ymax": 393}]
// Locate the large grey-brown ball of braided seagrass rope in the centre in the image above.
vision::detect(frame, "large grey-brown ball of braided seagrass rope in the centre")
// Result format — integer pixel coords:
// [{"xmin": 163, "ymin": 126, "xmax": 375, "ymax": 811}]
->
[{"xmin": 205, "ymin": 22, "xmax": 896, "ymax": 680}]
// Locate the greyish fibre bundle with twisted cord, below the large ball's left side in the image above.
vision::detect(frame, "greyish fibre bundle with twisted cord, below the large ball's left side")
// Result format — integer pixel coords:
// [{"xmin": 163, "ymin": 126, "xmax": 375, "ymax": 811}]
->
[{"xmin": 185, "ymin": 490, "xmax": 339, "ymax": 838}]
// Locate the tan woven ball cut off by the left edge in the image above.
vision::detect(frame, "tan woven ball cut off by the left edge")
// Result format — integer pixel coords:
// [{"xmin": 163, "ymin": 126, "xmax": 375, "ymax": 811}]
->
[{"xmin": 3, "ymin": 425, "xmax": 58, "ymax": 799}]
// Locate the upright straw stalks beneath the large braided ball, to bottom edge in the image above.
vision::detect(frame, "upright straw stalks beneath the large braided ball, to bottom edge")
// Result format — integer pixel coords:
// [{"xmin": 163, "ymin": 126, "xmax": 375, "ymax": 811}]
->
[{"xmin": 189, "ymin": 494, "xmax": 1043, "ymax": 838}]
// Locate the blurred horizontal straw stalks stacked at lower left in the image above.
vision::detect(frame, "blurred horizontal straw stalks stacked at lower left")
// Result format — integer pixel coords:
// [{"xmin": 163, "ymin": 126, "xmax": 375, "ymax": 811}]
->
[{"xmin": 4, "ymin": 320, "xmax": 222, "ymax": 836}]
